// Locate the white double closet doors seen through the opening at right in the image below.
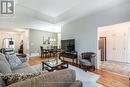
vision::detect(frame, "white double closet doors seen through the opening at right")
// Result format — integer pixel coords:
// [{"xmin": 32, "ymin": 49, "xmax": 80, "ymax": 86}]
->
[{"xmin": 102, "ymin": 29, "xmax": 130, "ymax": 62}]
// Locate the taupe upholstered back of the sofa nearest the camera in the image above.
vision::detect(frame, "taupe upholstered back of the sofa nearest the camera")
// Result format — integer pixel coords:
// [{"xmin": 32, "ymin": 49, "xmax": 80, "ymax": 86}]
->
[{"xmin": 8, "ymin": 69, "xmax": 83, "ymax": 87}]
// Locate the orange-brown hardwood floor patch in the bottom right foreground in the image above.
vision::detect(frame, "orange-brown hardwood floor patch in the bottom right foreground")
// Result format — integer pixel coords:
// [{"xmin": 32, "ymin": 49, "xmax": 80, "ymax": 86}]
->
[{"xmin": 94, "ymin": 70, "xmax": 130, "ymax": 87}]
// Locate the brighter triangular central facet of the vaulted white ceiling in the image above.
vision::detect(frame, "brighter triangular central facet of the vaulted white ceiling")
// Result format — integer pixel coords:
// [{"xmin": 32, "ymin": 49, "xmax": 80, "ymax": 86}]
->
[{"xmin": 18, "ymin": 0, "xmax": 82, "ymax": 17}]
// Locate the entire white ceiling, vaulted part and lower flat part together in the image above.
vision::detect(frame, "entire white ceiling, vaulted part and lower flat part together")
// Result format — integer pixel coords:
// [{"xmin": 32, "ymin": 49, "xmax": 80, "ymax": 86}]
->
[{"xmin": 0, "ymin": 0, "xmax": 129, "ymax": 30}]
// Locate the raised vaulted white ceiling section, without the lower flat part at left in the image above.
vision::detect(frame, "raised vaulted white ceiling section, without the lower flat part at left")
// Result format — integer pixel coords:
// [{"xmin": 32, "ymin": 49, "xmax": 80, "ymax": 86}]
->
[{"xmin": 16, "ymin": 0, "xmax": 129, "ymax": 23}]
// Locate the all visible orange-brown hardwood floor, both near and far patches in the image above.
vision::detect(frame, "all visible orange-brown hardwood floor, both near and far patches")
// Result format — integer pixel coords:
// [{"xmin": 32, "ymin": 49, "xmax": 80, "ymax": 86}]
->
[{"xmin": 29, "ymin": 57, "xmax": 130, "ymax": 87}]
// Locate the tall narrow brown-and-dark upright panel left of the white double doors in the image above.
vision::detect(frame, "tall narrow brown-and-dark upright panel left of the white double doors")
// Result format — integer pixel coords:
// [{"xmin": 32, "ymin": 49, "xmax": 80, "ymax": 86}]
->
[{"xmin": 99, "ymin": 37, "xmax": 106, "ymax": 61}]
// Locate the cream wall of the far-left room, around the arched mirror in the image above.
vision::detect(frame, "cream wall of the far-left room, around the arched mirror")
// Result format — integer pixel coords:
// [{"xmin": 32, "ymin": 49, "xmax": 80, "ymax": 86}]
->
[{"xmin": 0, "ymin": 28, "xmax": 29, "ymax": 53}]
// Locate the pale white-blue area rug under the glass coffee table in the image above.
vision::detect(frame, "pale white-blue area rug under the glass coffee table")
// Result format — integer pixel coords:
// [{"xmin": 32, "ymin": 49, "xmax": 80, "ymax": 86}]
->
[{"xmin": 32, "ymin": 64, "xmax": 103, "ymax": 87}]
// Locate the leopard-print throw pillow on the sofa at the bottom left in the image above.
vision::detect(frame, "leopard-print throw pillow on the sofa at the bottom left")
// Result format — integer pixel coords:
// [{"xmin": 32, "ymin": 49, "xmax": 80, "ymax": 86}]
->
[{"xmin": 0, "ymin": 72, "xmax": 45, "ymax": 86}]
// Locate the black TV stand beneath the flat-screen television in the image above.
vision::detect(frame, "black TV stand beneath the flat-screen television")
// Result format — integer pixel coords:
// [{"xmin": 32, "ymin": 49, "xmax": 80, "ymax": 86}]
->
[{"xmin": 59, "ymin": 51, "xmax": 78, "ymax": 64}]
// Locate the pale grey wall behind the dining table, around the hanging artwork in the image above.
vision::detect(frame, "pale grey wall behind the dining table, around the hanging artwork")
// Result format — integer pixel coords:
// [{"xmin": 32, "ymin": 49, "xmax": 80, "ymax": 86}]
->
[{"xmin": 29, "ymin": 29, "xmax": 58, "ymax": 54}]
